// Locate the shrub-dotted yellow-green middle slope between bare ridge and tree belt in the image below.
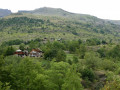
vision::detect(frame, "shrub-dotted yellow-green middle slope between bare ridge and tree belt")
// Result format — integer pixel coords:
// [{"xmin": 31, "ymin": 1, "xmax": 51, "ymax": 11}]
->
[{"xmin": 0, "ymin": 14, "xmax": 120, "ymax": 42}]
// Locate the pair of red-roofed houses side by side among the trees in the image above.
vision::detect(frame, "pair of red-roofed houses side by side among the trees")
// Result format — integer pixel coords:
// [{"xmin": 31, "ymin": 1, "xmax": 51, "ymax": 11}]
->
[{"xmin": 15, "ymin": 49, "xmax": 43, "ymax": 57}]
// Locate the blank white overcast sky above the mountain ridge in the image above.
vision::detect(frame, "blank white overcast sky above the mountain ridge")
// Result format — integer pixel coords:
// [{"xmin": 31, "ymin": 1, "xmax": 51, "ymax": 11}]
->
[{"xmin": 0, "ymin": 0, "xmax": 120, "ymax": 20}]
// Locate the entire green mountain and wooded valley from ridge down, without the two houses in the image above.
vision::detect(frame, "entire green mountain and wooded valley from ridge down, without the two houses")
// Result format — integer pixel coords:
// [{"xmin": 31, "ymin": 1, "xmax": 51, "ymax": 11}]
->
[{"xmin": 0, "ymin": 7, "xmax": 120, "ymax": 90}]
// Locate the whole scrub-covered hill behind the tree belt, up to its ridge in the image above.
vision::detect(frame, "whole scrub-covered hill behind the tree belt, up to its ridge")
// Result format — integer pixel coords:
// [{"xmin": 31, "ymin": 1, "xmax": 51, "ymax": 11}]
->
[{"xmin": 0, "ymin": 8, "xmax": 120, "ymax": 42}]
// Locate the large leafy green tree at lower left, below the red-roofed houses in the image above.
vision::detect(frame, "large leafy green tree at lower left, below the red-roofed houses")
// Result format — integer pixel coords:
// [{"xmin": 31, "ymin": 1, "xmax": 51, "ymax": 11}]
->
[{"xmin": 7, "ymin": 58, "xmax": 42, "ymax": 90}]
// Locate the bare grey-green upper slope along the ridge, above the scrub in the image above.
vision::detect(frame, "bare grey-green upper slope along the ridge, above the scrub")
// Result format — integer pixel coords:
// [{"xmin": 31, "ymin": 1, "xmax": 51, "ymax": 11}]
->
[{"xmin": 18, "ymin": 7, "xmax": 117, "ymax": 27}]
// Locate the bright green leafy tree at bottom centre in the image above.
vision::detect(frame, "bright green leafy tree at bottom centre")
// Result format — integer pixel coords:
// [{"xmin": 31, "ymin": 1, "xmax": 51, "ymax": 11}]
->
[{"xmin": 46, "ymin": 62, "xmax": 69, "ymax": 90}]
